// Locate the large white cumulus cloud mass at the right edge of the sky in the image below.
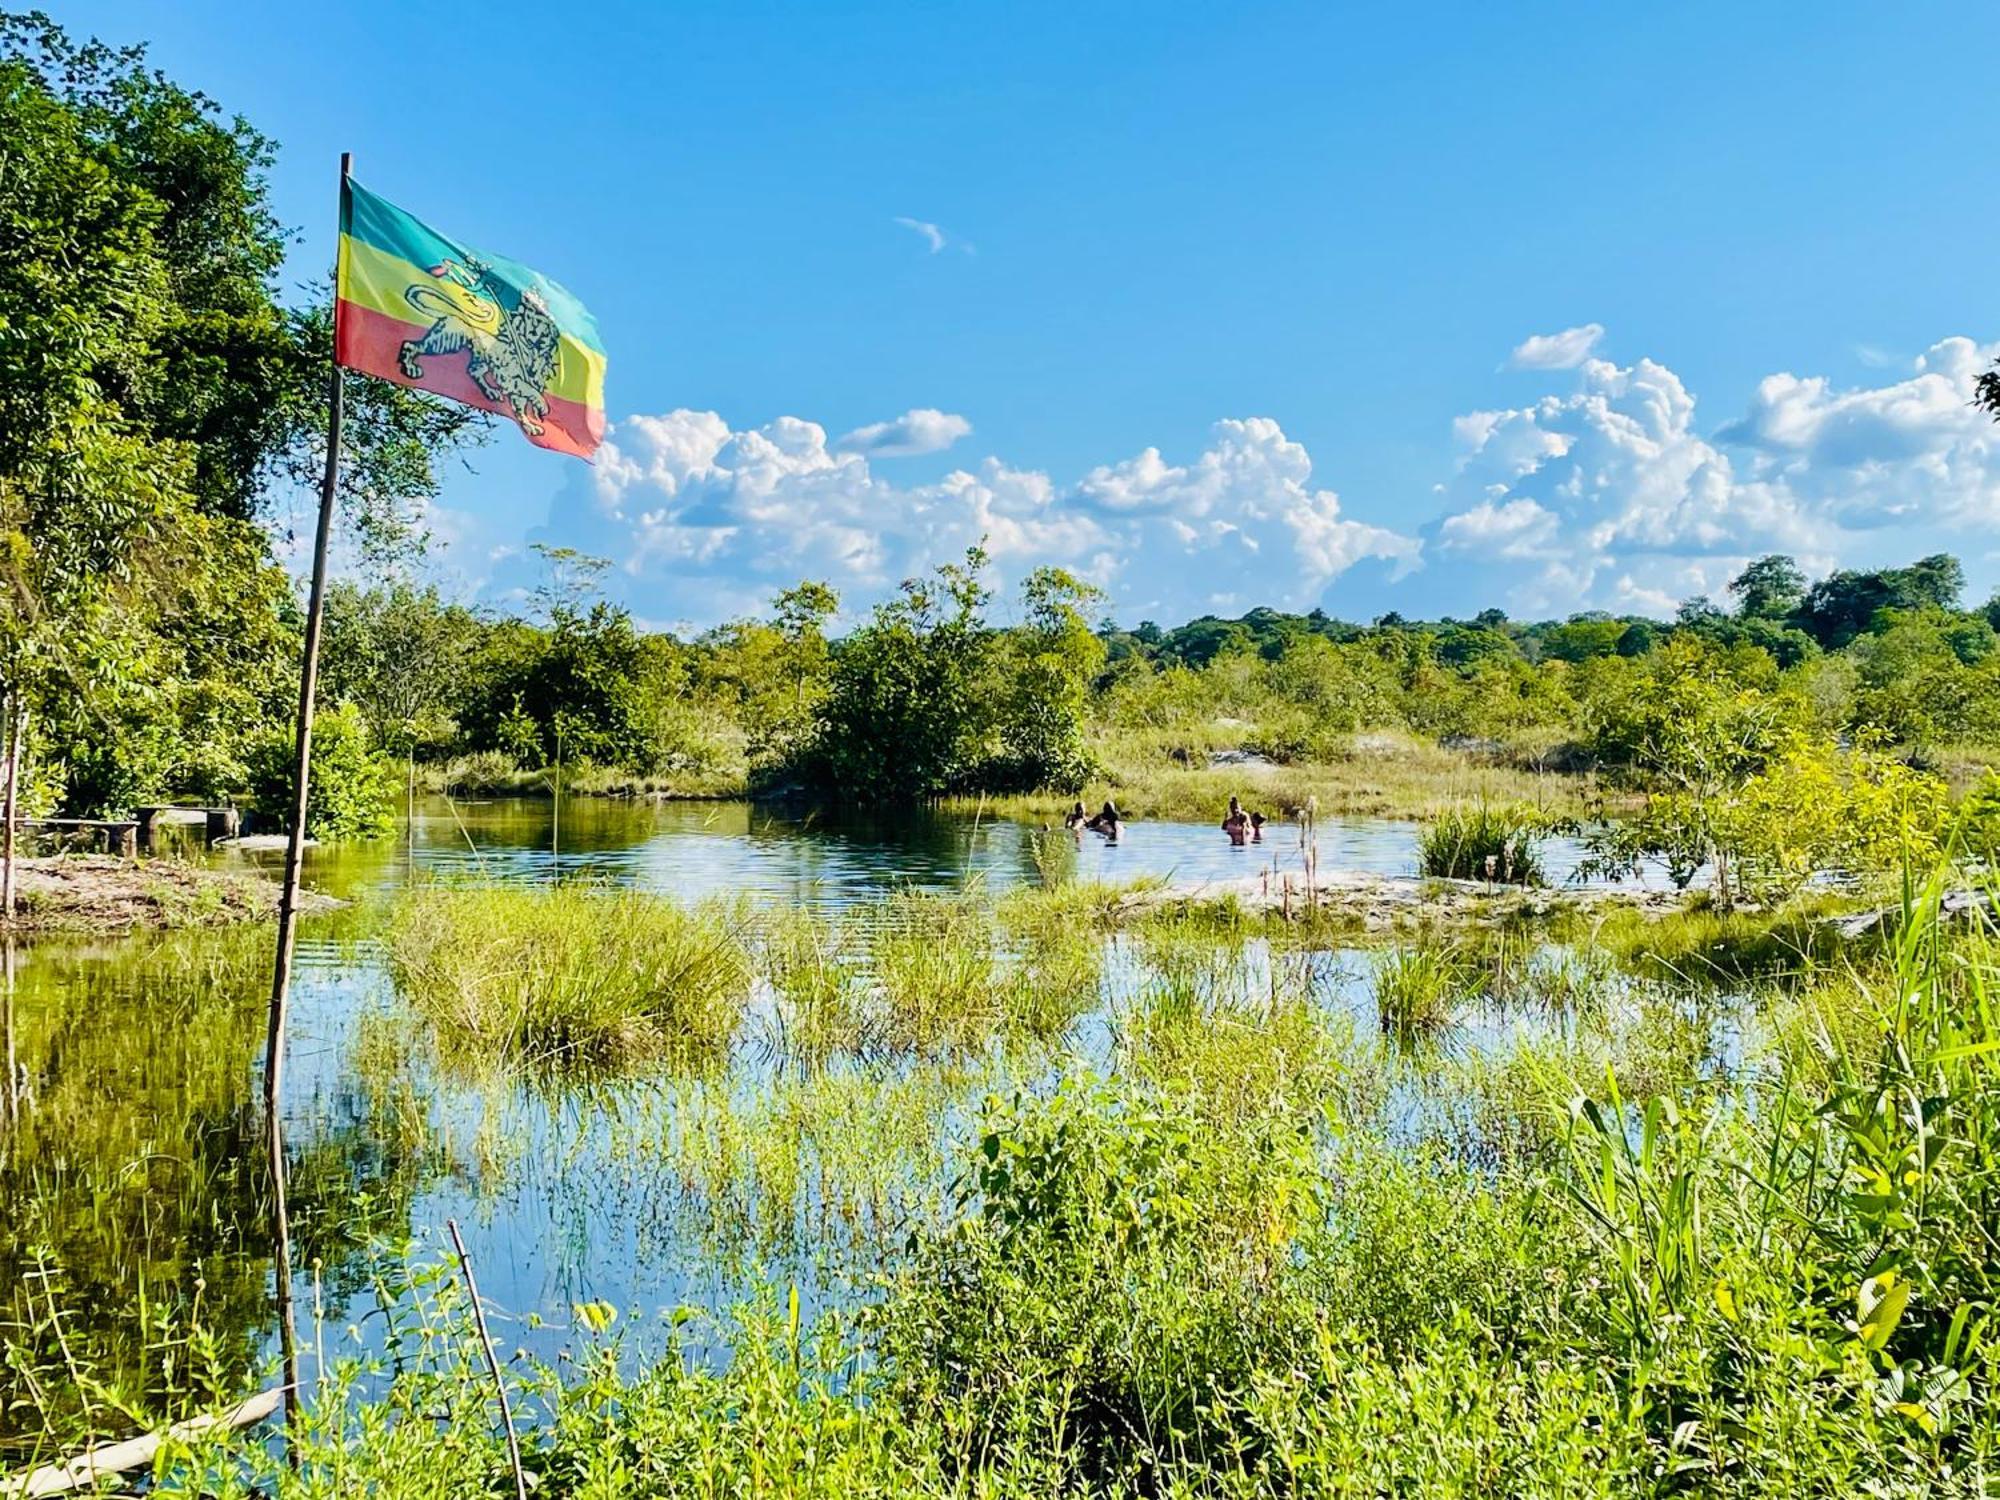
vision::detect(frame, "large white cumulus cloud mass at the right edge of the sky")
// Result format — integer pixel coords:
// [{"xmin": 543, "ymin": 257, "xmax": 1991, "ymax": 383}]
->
[{"xmin": 1428, "ymin": 338, "xmax": 2000, "ymax": 614}]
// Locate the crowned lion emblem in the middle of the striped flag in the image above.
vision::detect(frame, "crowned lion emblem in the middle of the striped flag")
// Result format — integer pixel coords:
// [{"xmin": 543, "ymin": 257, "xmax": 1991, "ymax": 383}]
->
[{"xmin": 396, "ymin": 256, "xmax": 562, "ymax": 438}]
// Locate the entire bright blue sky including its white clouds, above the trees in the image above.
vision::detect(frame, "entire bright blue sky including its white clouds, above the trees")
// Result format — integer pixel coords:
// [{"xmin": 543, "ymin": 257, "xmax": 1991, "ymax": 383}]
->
[{"xmin": 54, "ymin": 0, "xmax": 2000, "ymax": 626}]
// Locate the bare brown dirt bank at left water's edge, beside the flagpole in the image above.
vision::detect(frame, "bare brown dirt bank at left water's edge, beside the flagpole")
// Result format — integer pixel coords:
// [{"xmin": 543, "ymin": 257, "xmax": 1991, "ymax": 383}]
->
[{"xmin": 2, "ymin": 854, "xmax": 340, "ymax": 936}]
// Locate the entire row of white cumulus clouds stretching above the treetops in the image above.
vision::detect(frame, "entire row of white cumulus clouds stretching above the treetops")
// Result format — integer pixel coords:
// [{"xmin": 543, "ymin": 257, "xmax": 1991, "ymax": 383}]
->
[{"xmin": 480, "ymin": 330, "xmax": 2000, "ymax": 624}]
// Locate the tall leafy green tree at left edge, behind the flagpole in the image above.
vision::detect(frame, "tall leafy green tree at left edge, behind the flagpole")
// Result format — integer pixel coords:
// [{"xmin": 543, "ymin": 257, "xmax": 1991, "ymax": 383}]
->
[{"xmin": 0, "ymin": 14, "xmax": 478, "ymax": 848}]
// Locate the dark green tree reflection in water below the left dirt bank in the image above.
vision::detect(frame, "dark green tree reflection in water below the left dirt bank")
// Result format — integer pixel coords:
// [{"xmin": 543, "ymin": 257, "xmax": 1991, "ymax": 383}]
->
[{"xmin": 0, "ymin": 932, "xmax": 426, "ymax": 1466}]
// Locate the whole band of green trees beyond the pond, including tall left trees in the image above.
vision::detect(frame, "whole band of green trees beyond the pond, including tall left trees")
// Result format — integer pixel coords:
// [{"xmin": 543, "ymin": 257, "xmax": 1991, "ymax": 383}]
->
[{"xmin": 11, "ymin": 14, "xmax": 2000, "ymax": 848}]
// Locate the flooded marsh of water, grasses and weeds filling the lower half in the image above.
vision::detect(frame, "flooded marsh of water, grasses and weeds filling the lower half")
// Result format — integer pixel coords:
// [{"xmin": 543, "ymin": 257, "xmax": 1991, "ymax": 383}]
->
[{"xmin": 0, "ymin": 804, "xmax": 2000, "ymax": 1496}]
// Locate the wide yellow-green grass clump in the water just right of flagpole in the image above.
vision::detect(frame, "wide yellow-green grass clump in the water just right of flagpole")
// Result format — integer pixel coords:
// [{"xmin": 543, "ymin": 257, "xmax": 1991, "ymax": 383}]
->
[{"xmin": 388, "ymin": 886, "xmax": 750, "ymax": 1068}]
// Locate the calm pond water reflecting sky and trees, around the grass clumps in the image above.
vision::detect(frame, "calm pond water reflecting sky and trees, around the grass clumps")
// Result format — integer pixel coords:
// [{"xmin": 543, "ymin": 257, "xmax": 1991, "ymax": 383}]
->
[{"xmin": 0, "ymin": 800, "xmax": 1720, "ymax": 1452}]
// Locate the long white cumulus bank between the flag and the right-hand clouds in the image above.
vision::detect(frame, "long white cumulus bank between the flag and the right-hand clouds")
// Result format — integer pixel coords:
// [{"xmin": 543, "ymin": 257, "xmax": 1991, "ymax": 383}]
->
[{"xmin": 550, "ymin": 410, "xmax": 1420, "ymax": 624}]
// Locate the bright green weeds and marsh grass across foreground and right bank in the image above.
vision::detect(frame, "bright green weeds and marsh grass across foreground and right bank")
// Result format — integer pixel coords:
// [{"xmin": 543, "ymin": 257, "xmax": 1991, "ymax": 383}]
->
[{"xmin": 3, "ymin": 882, "xmax": 2000, "ymax": 1496}]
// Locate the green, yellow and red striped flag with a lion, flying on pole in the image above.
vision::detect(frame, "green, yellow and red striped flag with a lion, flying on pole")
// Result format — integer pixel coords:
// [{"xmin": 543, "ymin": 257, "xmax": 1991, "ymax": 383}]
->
[{"xmin": 334, "ymin": 178, "xmax": 604, "ymax": 458}]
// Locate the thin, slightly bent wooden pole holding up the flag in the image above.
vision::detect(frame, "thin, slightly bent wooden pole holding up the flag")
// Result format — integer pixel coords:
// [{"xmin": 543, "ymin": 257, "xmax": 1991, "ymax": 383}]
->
[{"xmin": 264, "ymin": 152, "xmax": 354, "ymax": 1432}]
